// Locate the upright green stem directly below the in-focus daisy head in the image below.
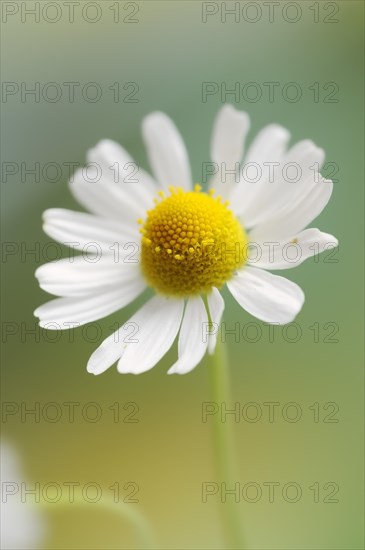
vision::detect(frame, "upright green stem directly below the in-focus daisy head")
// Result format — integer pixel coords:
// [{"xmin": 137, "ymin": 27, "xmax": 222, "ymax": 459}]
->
[{"xmin": 208, "ymin": 333, "xmax": 244, "ymax": 549}]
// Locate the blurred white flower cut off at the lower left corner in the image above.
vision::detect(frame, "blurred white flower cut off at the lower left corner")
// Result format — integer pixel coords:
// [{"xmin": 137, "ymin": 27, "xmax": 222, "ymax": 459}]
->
[{"xmin": 0, "ymin": 441, "xmax": 45, "ymax": 550}]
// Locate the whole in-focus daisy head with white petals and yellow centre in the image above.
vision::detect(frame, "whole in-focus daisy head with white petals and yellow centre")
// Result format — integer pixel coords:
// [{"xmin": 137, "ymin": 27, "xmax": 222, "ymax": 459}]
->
[{"xmin": 35, "ymin": 105, "xmax": 337, "ymax": 374}]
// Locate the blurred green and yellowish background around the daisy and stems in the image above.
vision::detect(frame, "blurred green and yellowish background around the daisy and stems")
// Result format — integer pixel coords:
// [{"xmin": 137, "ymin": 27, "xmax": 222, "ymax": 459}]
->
[{"xmin": 2, "ymin": 1, "xmax": 364, "ymax": 549}]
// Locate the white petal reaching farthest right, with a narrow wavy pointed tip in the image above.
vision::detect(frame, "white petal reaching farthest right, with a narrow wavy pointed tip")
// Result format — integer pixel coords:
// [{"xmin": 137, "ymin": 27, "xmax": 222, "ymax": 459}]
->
[{"xmin": 248, "ymin": 228, "xmax": 338, "ymax": 269}]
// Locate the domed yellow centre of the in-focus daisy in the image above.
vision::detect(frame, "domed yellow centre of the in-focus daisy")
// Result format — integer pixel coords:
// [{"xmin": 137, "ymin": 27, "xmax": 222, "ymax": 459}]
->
[{"xmin": 139, "ymin": 185, "xmax": 248, "ymax": 297}]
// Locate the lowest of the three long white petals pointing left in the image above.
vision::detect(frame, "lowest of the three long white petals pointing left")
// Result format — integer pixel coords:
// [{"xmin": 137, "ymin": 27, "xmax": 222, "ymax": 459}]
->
[{"xmin": 34, "ymin": 279, "xmax": 146, "ymax": 330}]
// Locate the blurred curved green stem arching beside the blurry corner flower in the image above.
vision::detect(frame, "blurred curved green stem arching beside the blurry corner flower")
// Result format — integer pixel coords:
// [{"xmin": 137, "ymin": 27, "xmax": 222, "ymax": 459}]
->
[{"xmin": 38, "ymin": 495, "xmax": 157, "ymax": 550}]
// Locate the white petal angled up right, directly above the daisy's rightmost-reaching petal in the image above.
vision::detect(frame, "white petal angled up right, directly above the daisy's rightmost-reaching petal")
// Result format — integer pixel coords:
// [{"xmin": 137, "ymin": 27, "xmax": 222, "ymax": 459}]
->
[{"xmin": 250, "ymin": 178, "xmax": 333, "ymax": 243}]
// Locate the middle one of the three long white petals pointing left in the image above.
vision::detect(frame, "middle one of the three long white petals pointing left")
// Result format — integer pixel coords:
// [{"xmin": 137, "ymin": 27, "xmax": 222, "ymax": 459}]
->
[{"xmin": 35, "ymin": 256, "xmax": 141, "ymax": 296}]
